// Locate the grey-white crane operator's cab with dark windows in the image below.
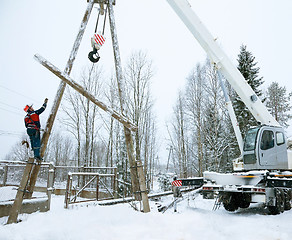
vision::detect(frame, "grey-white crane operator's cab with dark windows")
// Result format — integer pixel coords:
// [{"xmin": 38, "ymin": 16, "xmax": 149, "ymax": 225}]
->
[{"xmin": 243, "ymin": 125, "xmax": 289, "ymax": 170}]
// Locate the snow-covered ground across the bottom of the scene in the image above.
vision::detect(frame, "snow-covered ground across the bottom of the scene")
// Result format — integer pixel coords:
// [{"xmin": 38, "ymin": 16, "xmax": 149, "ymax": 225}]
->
[{"xmin": 0, "ymin": 188, "xmax": 292, "ymax": 240}]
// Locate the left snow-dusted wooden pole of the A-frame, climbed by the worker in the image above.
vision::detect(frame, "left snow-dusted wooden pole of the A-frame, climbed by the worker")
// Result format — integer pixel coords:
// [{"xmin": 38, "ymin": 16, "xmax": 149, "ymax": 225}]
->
[{"xmin": 25, "ymin": 0, "xmax": 94, "ymax": 198}]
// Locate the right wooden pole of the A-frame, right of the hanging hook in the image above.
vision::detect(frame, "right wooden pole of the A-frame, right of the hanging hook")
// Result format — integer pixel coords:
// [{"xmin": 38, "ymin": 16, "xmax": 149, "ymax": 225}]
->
[{"xmin": 108, "ymin": 0, "xmax": 150, "ymax": 213}]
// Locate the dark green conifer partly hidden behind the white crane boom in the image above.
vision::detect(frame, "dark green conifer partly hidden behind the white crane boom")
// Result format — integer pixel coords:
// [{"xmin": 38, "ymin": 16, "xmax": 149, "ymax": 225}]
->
[{"xmin": 231, "ymin": 45, "xmax": 264, "ymax": 135}]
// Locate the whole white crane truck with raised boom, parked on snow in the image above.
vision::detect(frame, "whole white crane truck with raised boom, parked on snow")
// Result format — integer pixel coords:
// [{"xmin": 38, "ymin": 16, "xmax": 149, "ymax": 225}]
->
[{"xmin": 167, "ymin": 0, "xmax": 292, "ymax": 214}]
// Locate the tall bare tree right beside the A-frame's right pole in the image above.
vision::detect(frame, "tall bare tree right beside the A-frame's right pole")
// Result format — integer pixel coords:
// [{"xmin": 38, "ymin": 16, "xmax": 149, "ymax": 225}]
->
[{"xmin": 124, "ymin": 51, "xmax": 156, "ymax": 188}]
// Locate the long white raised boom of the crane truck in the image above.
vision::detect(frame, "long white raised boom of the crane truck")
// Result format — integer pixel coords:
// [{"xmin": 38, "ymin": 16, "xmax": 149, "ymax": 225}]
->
[{"xmin": 167, "ymin": 0, "xmax": 280, "ymax": 126}]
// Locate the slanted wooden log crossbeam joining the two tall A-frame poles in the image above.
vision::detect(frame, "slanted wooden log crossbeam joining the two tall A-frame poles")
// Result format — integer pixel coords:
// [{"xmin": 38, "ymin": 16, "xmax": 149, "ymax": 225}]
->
[{"xmin": 34, "ymin": 54, "xmax": 137, "ymax": 131}]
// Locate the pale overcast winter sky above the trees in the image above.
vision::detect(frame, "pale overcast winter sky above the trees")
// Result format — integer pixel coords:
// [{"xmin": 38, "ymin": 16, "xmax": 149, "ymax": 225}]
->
[{"xmin": 0, "ymin": 0, "xmax": 292, "ymax": 159}]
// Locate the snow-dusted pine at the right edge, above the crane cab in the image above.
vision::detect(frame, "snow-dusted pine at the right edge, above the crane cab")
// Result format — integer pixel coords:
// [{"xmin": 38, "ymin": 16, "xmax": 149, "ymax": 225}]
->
[{"xmin": 266, "ymin": 82, "xmax": 292, "ymax": 127}]
